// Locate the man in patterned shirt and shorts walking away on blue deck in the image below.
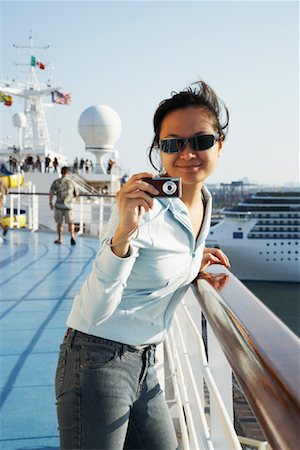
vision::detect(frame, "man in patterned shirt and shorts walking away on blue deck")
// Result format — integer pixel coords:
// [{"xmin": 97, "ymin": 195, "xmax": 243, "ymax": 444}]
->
[{"xmin": 49, "ymin": 166, "xmax": 79, "ymax": 245}]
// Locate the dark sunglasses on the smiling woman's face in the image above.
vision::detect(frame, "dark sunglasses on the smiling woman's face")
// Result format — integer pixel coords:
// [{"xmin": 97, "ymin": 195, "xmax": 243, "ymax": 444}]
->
[{"xmin": 159, "ymin": 133, "xmax": 220, "ymax": 153}]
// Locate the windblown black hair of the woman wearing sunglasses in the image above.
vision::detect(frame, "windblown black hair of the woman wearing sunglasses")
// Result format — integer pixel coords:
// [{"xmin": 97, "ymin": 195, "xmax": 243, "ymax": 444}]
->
[{"xmin": 148, "ymin": 80, "xmax": 229, "ymax": 170}]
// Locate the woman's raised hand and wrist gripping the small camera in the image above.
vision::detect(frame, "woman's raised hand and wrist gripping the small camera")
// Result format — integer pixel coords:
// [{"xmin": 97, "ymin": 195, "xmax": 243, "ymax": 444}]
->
[{"xmin": 111, "ymin": 172, "xmax": 158, "ymax": 258}]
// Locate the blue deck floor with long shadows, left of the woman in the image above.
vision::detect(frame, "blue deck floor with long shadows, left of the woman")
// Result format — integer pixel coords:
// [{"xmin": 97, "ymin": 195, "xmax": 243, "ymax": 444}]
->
[{"xmin": 0, "ymin": 230, "xmax": 99, "ymax": 450}]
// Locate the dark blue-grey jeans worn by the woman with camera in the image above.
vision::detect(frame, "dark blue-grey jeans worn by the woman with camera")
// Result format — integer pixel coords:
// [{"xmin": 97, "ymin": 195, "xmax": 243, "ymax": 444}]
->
[{"xmin": 55, "ymin": 329, "xmax": 178, "ymax": 450}]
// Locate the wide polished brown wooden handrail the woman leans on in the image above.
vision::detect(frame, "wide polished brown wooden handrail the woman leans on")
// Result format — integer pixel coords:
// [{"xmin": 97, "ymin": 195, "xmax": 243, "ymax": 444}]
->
[{"xmin": 193, "ymin": 266, "xmax": 300, "ymax": 450}]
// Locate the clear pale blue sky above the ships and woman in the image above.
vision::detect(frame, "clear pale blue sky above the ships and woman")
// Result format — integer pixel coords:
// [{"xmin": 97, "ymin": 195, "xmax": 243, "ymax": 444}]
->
[{"xmin": 0, "ymin": 1, "xmax": 299, "ymax": 185}]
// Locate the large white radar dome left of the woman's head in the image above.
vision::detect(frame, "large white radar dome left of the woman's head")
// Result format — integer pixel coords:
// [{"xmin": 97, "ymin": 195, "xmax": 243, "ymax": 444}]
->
[{"xmin": 78, "ymin": 105, "xmax": 122, "ymax": 150}]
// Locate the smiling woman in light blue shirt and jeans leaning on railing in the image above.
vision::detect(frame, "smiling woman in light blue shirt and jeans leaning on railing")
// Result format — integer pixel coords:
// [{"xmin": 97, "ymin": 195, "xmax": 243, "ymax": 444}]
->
[{"xmin": 56, "ymin": 82, "xmax": 229, "ymax": 450}]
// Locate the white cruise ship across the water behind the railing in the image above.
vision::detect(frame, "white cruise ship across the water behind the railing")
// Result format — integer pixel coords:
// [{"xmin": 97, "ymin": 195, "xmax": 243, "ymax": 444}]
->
[{"xmin": 207, "ymin": 191, "xmax": 300, "ymax": 282}]
